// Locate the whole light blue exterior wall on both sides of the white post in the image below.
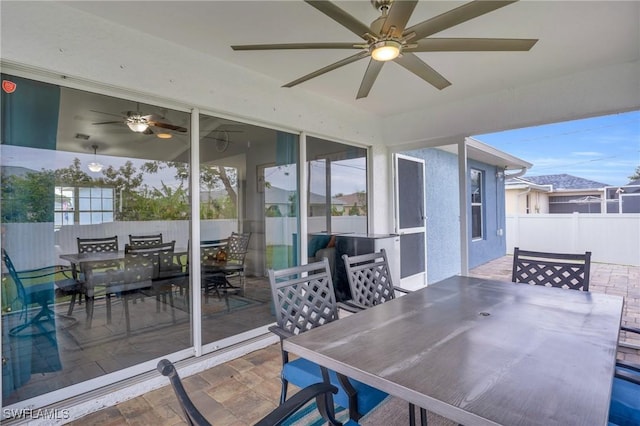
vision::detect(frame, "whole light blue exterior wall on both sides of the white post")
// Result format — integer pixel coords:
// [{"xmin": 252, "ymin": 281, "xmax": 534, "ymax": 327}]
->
[{"xmin": 403, "ymin": 148, "xmax": 506, "ymax": 284}]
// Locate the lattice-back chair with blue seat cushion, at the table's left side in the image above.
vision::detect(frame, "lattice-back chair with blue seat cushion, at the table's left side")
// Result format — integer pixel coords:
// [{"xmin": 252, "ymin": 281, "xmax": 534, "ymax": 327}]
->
[{"xmin": 269, "ymin": 258, "xmax": 387, "ymax": 424}]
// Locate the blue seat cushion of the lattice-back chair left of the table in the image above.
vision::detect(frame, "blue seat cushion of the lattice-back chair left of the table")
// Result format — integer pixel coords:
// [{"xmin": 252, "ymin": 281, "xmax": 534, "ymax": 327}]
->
[{"xmin": 282, "ymin": 358, "xmax": 387, "ymax": 415}]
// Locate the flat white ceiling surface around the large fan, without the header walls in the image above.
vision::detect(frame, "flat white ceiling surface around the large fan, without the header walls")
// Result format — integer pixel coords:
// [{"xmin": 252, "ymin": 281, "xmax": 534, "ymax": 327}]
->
[{"xmin": 65, "ymin": 0, "xmax": 640, "ymax": 116}]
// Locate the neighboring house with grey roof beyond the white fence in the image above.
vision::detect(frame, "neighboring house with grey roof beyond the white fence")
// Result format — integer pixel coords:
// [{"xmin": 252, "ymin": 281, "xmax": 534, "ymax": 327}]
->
[{"xmin": 505, "ymin": 174, "xmax": 607, "ymax": 214}]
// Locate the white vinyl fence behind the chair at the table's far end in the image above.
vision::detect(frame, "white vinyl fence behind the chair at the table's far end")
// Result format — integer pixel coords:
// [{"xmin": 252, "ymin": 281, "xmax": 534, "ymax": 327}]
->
[{"xmin": 507, "ymin": 213, "xmax": 640, "ymax": 266}]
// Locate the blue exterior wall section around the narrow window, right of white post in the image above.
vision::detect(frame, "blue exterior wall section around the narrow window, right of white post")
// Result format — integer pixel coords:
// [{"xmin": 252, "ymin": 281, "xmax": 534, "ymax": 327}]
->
[{"xmin": 466, "ymin": 160, "xmax": 506, "ymax": 268}]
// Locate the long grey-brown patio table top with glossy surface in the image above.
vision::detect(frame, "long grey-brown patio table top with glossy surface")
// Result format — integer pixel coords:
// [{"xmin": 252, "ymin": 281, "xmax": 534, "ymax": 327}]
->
[{"xmin": 284, "ymin": 276, "xmax": 623, "ymax": 426}]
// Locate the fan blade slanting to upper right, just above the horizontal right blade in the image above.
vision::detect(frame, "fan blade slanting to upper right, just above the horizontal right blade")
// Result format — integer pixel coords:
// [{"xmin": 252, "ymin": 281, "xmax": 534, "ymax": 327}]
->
[{"xmin": 404, "ymin": 0, "xmax": 517, "ymax": 41}]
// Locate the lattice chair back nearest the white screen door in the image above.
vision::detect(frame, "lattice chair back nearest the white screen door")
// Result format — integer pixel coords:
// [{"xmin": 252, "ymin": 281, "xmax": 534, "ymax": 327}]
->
[{"xmin": 342, "ymin": 249, "xmax": 395, "ymax": 308}]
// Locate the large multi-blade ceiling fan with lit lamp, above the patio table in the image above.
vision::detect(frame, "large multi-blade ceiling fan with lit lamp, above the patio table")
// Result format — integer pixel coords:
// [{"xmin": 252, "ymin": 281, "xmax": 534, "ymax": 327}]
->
[{"xmin": 231, "ymin": 0, "xmax": 538, "ymax": 99}]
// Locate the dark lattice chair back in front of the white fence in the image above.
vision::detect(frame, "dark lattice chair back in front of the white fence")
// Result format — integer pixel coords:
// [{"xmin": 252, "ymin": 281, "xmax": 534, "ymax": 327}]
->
[{"xmin": 511, "ymin": 247, "xmax": 591, "ymax": 291}]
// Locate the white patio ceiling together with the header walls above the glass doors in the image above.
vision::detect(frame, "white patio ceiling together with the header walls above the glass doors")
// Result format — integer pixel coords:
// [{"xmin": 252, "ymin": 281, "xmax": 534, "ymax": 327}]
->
[{"xmin": 2, "ymin": 0, "xmax": 640, "ymax": 149}]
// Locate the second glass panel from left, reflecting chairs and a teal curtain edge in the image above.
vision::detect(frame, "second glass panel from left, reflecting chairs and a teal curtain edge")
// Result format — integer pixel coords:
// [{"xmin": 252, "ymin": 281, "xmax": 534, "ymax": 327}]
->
[{"xmin": 200, "ymin": 115, "xmax": 298, "ymax": 344}]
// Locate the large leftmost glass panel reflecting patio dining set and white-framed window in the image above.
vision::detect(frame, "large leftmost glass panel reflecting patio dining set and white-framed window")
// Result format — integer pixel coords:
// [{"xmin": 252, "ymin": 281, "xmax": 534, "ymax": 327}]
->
[{"xmin": 0, "ymin": 75, "xmax": 192, "ymax": 407}]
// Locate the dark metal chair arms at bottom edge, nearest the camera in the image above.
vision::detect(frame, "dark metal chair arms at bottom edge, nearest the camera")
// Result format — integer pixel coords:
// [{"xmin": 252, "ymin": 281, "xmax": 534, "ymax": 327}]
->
[{"xmin": 157, "ymin": 359, "xmax": 340, "ymax": 426}]
